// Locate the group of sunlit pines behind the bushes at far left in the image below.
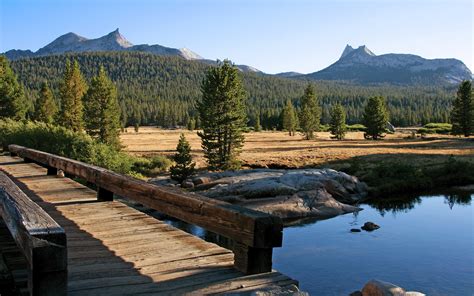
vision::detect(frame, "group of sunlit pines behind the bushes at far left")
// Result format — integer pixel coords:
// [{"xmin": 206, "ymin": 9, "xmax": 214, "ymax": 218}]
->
[{"xmin": 0, "ymin": 56, "xmax": 120, "ymax": 149}]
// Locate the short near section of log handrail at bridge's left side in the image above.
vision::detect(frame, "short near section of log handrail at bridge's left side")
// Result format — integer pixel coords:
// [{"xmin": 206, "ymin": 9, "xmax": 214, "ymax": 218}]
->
[{"xmin": 0, "ymin": 171, "xmax": 67, "ymax": 295}]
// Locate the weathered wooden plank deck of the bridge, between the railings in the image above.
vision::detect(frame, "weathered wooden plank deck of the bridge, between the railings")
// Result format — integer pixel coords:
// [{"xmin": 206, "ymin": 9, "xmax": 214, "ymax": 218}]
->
[{"xmin": 0, "ymin": 156, "xmax": 297, "ymax": 295}]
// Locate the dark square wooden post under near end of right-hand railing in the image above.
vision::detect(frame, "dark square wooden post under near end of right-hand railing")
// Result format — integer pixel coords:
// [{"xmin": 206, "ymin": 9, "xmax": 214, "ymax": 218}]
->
[{"xmin": 233, "ymin": 242, "xmax": 273, "ymax": 274}]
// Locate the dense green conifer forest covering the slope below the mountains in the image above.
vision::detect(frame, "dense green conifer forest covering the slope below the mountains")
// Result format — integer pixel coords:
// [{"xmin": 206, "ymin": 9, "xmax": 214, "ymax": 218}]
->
[{"xmin": 6, "ymin": 52, "xmax": 456, "ymax": 130}]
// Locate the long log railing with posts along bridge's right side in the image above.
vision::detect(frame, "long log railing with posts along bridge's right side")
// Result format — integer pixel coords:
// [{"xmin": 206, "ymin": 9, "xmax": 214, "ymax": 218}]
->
[{"xmin": 9, "ymin": 145, "xmax": 283, "ymax": 274}]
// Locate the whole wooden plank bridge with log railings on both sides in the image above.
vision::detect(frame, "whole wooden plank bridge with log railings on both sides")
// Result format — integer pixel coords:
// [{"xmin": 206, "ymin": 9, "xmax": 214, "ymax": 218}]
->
[{"xmin": 0, "ymin": 145, "xmax": 298, "ymax": 296}]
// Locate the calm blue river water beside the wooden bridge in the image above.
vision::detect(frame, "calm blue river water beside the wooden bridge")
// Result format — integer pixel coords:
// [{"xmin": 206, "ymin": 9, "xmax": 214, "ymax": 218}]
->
[{"xmin": 165, "ymin": 194, "xmax": 474, "ymax": 296}]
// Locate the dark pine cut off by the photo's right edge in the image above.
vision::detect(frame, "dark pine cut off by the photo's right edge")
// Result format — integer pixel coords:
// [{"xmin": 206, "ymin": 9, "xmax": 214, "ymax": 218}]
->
[{"xmin": 451, "ymin": 80, "xmax": 474, "ymax": 137}]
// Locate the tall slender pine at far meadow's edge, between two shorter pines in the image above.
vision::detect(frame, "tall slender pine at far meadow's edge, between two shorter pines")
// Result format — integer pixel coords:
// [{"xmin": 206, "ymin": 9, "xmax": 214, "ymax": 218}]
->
[{"xmin": 299, "ymin": 84, "xmax": 321, "ymax": 140}]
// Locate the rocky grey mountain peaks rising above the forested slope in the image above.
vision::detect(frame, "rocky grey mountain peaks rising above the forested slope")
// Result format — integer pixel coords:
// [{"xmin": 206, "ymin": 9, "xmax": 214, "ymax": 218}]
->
[{"xmin": 4, "ymin": 29, "xmax": 472, "ymax": 85}]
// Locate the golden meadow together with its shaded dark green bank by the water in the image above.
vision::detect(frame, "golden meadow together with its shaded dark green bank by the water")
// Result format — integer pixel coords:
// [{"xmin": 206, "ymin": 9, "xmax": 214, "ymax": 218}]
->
[{"xmin": 121, "ymin": 127, "xmax": 474, "ymax": 197}]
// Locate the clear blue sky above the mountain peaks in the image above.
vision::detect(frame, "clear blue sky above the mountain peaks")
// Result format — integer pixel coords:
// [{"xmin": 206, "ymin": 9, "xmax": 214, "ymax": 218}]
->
[{"xmin": 0, "ymin": 0, "xmax": 474, "ymax": 73}]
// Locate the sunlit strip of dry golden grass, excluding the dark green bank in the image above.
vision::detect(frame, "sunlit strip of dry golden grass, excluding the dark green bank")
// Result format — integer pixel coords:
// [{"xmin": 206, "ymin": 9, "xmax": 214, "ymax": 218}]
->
[{"xmin": 121, "ymin": 127, "xmax": 474, "ymax": 168}]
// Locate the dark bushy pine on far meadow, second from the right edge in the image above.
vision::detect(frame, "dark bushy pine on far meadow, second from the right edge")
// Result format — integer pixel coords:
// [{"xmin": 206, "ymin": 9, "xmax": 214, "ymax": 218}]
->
[{"xmin": 363, "ymin": 97, "xmax": 388, "ymax": 140}]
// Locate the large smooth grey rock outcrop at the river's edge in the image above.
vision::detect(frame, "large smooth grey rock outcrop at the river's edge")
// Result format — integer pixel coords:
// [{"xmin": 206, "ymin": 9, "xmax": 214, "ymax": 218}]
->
[{"xmin": 154, "ymin": 169, "xmax": 367, "ymax": 219}]
